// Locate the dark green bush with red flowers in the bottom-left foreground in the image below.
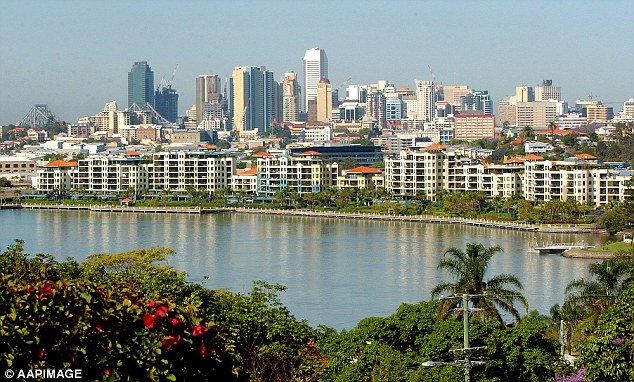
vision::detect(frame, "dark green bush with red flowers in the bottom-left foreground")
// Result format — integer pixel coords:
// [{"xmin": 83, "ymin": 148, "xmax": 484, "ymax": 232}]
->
[{"xmin": 0, "ymin": 240, "xmax": 238, "ymax": 381}]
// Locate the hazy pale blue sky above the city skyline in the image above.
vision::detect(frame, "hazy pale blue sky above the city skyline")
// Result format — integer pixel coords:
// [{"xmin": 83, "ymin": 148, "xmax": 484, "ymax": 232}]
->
[{"xmin": 0, "ymin": 0, "xmax": 634, "ymax": 124}]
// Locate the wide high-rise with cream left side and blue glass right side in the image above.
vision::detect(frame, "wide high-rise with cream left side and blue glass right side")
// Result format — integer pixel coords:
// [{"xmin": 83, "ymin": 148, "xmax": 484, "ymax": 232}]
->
[{"xmin": 231, "ymin": 66, "xmax": 281, "ymax": 132}]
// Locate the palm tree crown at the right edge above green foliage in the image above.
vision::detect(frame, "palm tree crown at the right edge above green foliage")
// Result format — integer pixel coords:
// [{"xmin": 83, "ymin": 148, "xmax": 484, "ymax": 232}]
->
[{"xmin": 564, "ymin": 255, "xmax": 632, "ymax": 311}]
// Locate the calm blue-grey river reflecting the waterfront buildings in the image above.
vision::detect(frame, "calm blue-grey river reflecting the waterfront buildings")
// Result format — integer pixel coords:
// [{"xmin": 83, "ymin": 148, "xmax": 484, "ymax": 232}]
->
[{"xmin": 0, "ymin": 210, "xmax": 606, "ymax": 330}]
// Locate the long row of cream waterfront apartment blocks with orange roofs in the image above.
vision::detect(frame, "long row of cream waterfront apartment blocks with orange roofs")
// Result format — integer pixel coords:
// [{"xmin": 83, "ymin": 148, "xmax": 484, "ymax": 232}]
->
[{"xmin": 33, "ymin": 148, "xmax": 634, "ymax": 206}]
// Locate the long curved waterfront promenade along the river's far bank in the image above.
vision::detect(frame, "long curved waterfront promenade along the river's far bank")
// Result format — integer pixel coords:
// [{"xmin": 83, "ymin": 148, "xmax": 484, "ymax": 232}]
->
[{"xmin": 2, "ymin": 204, "xmax": 597, "ymax": 233}]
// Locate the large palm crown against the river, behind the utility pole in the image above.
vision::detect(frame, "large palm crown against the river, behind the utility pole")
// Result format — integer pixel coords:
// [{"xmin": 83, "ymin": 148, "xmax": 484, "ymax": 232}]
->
[{"xmin": 431, "ymin": 243, "xmax": 528, "ymax": 321}]
